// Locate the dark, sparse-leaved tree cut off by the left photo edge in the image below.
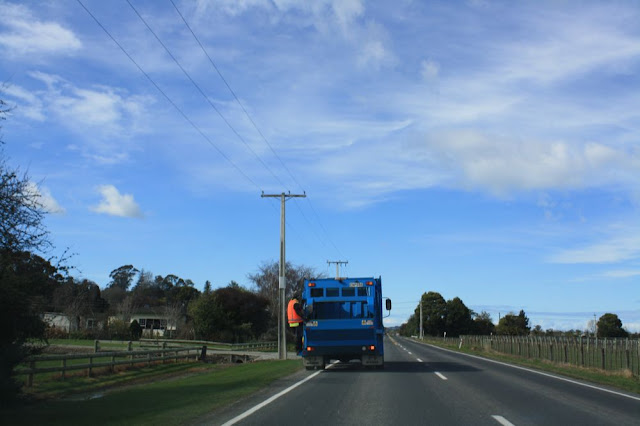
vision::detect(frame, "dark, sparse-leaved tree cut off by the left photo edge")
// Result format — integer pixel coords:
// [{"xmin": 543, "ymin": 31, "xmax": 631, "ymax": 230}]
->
[{"xmin": 0, "ymin": 94, "xmax": 62, "ymax": 403}]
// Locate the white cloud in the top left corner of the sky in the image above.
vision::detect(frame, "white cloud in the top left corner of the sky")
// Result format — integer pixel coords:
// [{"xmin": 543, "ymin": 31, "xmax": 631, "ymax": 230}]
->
[{"xmin": 0, "ymin": 2, "xmax": 82, "ymax": 55}]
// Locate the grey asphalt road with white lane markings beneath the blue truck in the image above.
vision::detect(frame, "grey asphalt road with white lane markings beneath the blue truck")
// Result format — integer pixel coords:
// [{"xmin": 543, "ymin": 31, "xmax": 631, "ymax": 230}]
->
[{"xmin": 210, "ymin": 337, "xmax": 640, "ymax": 426}]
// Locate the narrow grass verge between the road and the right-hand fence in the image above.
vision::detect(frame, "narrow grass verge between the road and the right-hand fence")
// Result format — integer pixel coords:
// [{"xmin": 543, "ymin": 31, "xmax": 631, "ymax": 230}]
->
[{"xmin": 412, "ymin": 339, "xmax": 640, "ymax": 394}]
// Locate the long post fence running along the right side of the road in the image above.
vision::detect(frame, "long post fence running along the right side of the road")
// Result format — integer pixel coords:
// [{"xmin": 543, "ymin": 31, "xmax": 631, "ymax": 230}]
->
[{"xmin": 439, "ymin": 336, "xmax": 640, "ymax": 377}]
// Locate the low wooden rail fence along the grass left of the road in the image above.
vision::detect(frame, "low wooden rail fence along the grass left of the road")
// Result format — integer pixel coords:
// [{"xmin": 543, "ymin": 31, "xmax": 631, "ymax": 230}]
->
[{"xmin": 14, "ymin": 341, "xmax": 202, "ymax": 387}]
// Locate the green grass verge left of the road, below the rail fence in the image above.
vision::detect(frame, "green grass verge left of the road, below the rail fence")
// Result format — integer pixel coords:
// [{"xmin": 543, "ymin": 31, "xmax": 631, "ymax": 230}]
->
[{"xmin": 0, "ymin": 360, "xmax": 302, "ymax": 425}]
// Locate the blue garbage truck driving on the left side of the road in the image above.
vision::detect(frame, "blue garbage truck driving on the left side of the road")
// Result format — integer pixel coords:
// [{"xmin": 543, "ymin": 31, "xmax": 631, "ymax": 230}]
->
[{"xmin": 300, "ymin": 278, "xmax": 391, "ymax": 370}]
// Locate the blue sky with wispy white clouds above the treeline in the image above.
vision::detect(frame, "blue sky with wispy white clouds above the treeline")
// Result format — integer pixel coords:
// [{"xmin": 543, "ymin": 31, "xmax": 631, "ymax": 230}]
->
[{"xmin": 0, "ymin": 0, "xmax": 640, "ymax": 331}]
